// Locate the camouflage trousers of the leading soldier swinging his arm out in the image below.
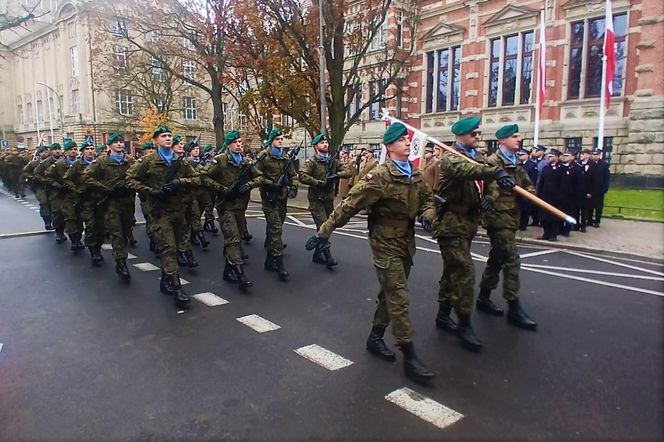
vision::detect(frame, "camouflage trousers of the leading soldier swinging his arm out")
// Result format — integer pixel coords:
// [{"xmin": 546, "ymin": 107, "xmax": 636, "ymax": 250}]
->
[{"xmin": 373, "ymin": 250, "xmax": 414, "ymax": 344}]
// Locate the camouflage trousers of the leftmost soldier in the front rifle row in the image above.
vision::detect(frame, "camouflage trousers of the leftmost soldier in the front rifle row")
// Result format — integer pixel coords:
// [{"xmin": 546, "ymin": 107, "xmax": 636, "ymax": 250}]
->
[{"xmin": 150, "ymin": 209, "xmax": 191, "ymax": 275}]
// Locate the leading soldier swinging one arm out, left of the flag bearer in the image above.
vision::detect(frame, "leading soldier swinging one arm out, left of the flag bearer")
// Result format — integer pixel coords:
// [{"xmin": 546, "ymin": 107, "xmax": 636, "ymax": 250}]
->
[{"xmin": 307, "ymin": 123, "xmax": 436, "ymax": 381}]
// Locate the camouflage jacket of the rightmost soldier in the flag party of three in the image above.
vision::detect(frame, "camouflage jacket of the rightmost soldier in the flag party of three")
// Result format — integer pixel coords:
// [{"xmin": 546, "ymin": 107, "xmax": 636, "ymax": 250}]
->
[{"xmin": 482, "ymin": 151, "xmax": 535, "ymax": 230}]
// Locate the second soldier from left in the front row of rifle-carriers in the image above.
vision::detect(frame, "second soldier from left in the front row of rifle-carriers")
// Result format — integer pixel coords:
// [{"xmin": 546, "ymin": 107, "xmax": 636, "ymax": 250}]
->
[{"xmin": 203, "ymin": 130, "xmax": 266, "ymax": 289}]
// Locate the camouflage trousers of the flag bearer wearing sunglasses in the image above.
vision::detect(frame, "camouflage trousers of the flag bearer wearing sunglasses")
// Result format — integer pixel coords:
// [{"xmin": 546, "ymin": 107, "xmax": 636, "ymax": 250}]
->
[{"xmin": 438, "ymin": 236, "xmax": 475, "ymax": 316}]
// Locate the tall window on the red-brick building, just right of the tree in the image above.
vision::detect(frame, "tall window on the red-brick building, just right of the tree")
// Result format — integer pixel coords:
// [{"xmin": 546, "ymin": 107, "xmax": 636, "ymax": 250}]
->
[{"xmin": 426, "ymin": 46, "xmax": 461, "ymax": 113}]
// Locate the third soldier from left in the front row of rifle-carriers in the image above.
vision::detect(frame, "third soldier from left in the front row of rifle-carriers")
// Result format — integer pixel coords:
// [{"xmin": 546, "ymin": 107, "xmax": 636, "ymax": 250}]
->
[{"xmin": 256, "ymin": 129, "xmax": 298, "ymax": 281}]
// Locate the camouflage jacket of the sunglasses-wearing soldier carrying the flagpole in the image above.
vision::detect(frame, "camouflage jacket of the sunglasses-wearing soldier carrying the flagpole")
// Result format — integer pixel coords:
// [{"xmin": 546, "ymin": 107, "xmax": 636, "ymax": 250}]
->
[{"xmin": 433, "ymin": 146, "xmax": 498, "ymax": 238}]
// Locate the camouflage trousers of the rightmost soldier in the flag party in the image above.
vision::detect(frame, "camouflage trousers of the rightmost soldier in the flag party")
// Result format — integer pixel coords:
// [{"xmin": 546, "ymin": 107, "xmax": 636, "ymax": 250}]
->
[{"xmin": 480, "ymin": 229, "xmax": 521, "ymax": 301}]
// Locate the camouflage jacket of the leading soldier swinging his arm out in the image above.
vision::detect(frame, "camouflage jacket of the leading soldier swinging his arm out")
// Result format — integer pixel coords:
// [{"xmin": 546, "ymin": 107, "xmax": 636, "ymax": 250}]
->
[{"xmin": 320, "ymin": 159, "xmax": 435, "ymax": 258}]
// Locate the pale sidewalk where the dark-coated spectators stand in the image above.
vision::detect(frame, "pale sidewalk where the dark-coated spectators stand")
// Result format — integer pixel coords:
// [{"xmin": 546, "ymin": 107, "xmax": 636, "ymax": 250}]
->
[{"xmin": 251, "ymin": 188, "xmax": 664, "ymax": 261}]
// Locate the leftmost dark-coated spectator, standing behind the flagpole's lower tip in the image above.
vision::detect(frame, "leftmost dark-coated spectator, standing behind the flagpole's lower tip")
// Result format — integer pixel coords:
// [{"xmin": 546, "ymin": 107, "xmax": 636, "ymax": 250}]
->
[{"xmin": 537, "ymin": 149, "xmax": 563, "ymax": 241}]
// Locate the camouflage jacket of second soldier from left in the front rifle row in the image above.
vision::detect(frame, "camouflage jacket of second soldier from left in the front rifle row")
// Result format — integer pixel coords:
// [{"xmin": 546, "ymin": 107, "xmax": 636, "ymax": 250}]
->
[{"xmin": 201, "ymin": 151, "xmax": 267, "ymax": 210}]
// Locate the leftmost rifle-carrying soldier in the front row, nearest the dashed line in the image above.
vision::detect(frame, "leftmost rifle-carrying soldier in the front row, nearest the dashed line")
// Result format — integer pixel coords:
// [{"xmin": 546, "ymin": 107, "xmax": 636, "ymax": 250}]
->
[{"xmin": 127, "ymin": 126, "xmax": 223, "ymax": 308}]
